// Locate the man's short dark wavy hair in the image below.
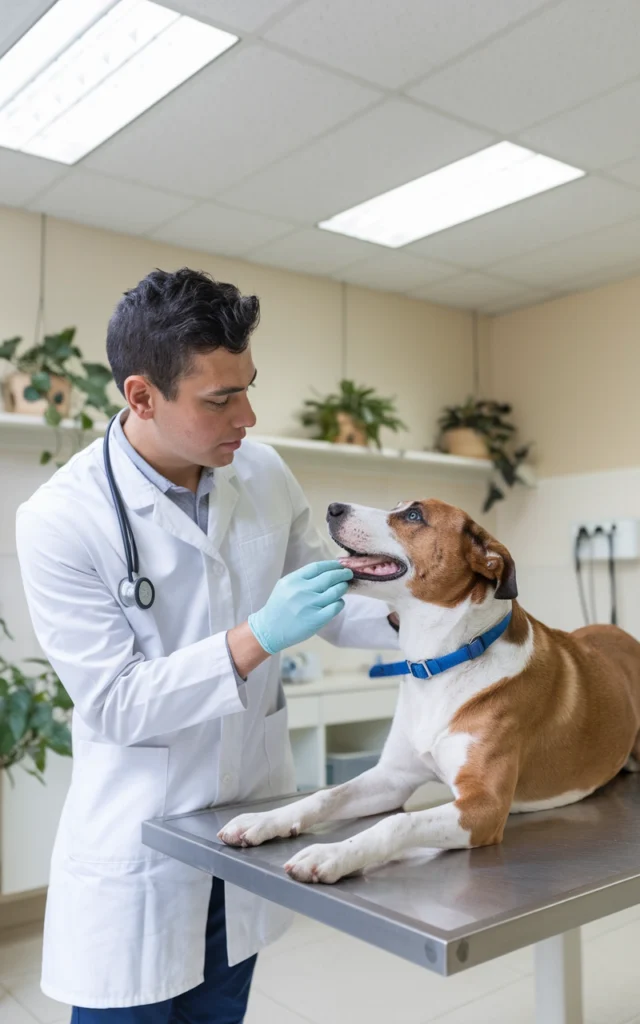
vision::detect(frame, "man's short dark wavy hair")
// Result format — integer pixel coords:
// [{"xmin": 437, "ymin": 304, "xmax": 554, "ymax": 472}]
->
[{"xmin": 106, "ymin": 267, "xmax": 260, "ymax": 400}]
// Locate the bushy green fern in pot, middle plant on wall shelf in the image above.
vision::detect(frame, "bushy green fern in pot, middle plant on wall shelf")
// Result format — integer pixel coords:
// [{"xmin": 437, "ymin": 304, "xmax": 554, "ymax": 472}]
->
[{"xmin": 299, "ymin": 380, "xmax": 407, "ymax": 449}]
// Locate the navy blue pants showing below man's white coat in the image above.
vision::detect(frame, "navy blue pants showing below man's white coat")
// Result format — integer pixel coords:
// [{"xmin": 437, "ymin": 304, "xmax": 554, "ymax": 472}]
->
[{"xmin": 71, "ymin": 879, "xmax": 257, "ymax": 1024}]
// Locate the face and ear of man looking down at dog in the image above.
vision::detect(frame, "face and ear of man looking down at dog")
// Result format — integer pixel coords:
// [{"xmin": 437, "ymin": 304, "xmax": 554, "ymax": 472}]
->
[{"xmin": 154, "ymin": 347, "xmax": 256, "ymax": 468}]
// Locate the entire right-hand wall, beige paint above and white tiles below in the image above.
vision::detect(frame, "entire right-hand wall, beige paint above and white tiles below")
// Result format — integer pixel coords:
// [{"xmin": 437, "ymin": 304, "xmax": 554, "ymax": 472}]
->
[{"xmin": 485, "ymin": 278, "xmax": 640, "ymax": 637}]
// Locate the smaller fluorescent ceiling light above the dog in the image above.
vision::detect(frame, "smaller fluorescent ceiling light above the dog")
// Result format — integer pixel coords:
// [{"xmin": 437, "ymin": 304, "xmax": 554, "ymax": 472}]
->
[{"xmin": 318, "ymin": 142, "xmax": 585, "ymax": 249}]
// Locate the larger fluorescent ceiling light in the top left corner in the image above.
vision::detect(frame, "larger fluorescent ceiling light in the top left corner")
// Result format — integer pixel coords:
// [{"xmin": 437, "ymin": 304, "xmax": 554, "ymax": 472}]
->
[{"xmin": 0, "ymin": 0, "xmax": 238, "ymax": 164}]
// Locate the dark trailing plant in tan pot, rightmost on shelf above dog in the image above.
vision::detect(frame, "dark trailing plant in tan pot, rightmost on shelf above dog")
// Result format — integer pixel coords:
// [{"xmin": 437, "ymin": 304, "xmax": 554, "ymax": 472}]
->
[{"xmin": 438, "ymin": 397, "xmax": 531, "ymax": 512}]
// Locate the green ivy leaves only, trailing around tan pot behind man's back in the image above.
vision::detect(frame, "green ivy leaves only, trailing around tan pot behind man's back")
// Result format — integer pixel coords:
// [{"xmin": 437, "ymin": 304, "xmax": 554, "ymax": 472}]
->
[{"xmin": 0, "ymin": 327, "xmax": 119, "ymax": 465}]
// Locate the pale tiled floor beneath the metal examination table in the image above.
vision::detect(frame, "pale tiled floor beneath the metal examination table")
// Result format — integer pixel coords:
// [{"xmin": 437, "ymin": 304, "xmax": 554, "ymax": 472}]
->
[{"xmin": 0, "ymin": 907, "xmax": 640, "ymax": 1024}]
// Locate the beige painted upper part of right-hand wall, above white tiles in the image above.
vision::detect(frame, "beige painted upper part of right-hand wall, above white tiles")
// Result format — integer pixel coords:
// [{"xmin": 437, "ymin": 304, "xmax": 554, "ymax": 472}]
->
[{"xmin": 489, "ymin": 278, "xmax": 640, "ymax": 476}]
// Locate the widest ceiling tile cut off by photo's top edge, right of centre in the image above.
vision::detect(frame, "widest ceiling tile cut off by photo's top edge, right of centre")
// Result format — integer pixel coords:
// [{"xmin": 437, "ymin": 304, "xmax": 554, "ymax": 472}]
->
[{"xmin": 265, "ymin": 0, "xmax": 544, "ymax": 89}]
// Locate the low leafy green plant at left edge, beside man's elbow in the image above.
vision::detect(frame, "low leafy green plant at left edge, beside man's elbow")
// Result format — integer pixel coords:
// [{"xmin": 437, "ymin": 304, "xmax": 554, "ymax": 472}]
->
[{"xmin": 0, "ymin": 618, "xmax": 73, "ymax": 783}]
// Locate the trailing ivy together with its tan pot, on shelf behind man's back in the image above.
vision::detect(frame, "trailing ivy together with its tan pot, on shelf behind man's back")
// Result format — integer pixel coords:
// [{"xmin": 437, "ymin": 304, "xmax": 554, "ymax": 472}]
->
[{"xmin": 0, "ymin": 327, "xmax": 118, "ymax": 464}]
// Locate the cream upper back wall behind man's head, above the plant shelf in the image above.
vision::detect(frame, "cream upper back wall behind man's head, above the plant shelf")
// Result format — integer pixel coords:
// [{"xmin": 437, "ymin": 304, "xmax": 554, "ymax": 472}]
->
[{"xmin": 0, "ymin": 208, "xmax": 472, "ymax": 449}]
